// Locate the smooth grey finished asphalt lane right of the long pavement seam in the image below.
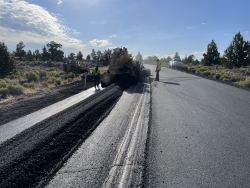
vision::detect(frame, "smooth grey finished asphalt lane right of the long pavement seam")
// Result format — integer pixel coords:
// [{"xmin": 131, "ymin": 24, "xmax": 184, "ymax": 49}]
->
[{"xmin": 145, "ymin": 65, "xmax": 250, "ymax": 188}]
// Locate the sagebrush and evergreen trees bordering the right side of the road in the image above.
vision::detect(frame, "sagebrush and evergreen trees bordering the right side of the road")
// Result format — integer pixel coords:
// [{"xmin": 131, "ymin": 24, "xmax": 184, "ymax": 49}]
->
[{"xmin": 144, "ymin": 32, "xmax": 250, "ymax": 88}]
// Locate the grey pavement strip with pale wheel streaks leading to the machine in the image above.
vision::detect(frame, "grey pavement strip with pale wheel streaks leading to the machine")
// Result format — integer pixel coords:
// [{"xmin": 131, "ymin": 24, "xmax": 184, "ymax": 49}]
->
[{"xmin": 47, "ymin": 80, "xmax": 150, "ymax": 188}]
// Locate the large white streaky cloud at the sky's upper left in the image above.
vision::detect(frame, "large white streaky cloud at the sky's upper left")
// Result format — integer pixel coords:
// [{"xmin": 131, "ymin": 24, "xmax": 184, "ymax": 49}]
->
[{"xmin": 0, "ymin": 0, "xmax": 86, "ymax": 49}]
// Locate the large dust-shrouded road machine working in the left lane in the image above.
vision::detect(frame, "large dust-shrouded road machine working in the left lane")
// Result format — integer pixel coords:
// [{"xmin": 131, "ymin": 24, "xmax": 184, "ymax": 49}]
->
[{"xmin": 101, "ymin": 47, "xmax": 150, "ymax": 87}]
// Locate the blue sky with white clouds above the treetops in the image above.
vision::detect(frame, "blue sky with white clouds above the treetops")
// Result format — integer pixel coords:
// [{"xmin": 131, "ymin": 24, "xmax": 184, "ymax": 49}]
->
[{"xmin": 0, "ymin": 0, "xmax": 250, "ymax": 60}]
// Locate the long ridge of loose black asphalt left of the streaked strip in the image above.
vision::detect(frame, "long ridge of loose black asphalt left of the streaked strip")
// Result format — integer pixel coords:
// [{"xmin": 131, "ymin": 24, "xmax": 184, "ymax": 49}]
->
[{"xmin": 0, "ymin": 84, "xmax": 125, "ymax": 188}]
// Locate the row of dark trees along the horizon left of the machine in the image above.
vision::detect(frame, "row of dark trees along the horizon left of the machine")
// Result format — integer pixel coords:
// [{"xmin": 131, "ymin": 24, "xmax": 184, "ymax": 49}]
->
[{"xmin": 0, "ymin": 41, "xmax": 113, "ymax": 77}]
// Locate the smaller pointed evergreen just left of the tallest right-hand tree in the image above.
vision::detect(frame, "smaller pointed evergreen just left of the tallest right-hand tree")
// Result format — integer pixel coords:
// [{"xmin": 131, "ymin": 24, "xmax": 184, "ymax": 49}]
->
[{"xmin": 203, "ymin": 40, "xmax": 220, "ymax": 66}]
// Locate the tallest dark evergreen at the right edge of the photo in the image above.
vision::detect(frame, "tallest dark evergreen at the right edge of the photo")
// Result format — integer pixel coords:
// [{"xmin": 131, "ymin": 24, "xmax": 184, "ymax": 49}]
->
[{"xmin": 224, "ymin": 32, "xmax": 248, "ymax": 68}]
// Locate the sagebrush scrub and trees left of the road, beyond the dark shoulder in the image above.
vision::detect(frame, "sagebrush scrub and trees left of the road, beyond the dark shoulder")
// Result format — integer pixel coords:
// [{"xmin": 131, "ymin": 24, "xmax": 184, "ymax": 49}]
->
[{"xmin": 0, "ymin": 41, "xmax": 109, "ymax": 99}]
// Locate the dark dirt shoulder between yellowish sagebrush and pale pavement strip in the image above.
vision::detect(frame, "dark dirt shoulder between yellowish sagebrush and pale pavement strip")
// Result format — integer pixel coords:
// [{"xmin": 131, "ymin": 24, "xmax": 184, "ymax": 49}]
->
[{"xmin": 0, "ymin": 78, "xmax": 93, "ymax": 125}]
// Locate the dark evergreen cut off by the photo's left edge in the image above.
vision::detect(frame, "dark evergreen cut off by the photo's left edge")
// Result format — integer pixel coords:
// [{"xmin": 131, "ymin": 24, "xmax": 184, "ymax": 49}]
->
[{"xmin": 0, "ymin": 42, "xmax": 17, "ymax": 77}]
